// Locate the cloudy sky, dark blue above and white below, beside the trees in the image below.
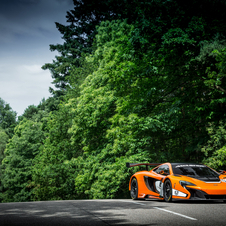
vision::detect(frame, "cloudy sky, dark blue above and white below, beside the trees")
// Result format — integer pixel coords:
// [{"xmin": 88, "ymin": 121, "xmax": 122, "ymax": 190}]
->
[{"xmin": 0, "ymin": 0, "xmax": 74, "ymax": 116}]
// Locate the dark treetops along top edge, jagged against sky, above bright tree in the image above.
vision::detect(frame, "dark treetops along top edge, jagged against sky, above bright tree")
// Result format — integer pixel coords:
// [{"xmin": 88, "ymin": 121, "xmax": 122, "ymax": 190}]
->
[{"xmin": 43, "ymin": 0, "xmax": 225, "ymax": 95}]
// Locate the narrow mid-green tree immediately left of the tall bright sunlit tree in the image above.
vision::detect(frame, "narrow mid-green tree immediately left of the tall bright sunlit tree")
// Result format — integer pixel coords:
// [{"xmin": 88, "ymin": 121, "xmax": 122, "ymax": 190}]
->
[{"xmin": 32, "ymin": 98, "xmax": 76, "ymax": 200}]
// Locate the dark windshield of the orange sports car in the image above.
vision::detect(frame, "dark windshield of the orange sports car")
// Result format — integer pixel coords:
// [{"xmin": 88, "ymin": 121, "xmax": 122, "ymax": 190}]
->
[{"xmin": 172, "ymin": 164, "xmax": 219, "ymax": 177}]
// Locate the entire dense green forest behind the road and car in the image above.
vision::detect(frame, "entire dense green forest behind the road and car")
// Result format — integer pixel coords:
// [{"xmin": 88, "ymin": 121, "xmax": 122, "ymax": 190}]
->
[{"xmin": 0, "ymin": 0, "xmax": 226, "ymax": 202}]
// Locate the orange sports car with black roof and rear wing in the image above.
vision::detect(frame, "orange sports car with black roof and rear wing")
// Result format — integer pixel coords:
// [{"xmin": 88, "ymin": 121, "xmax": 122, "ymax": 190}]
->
[{"xmin": 126, "ymin": 163, "xmax": 226, "ymax": 202}]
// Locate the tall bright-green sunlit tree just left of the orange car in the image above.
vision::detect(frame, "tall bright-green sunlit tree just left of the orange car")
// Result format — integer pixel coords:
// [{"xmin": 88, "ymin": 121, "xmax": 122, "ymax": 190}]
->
[{"xmin": 69, "ymin": 21, "xmax": 168, "ymax": 198}]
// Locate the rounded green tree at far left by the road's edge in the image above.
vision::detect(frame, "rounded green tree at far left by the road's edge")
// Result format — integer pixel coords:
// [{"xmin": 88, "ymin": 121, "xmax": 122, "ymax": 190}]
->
[{"xmin": 2, "ymin": 119, "xmax": 44, "ymax": 202}]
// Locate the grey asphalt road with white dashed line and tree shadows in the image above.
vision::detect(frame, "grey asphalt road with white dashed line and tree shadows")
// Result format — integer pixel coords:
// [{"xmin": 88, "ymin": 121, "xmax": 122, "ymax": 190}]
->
[{"xmin": 0, "ymin": 199, "xmax": 226, "ymax": 226}]
